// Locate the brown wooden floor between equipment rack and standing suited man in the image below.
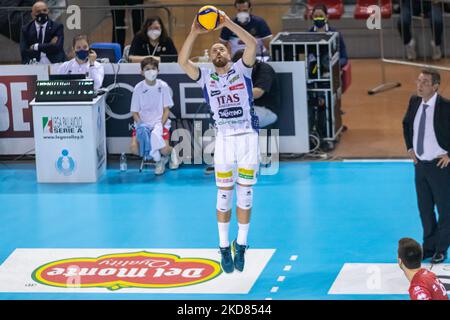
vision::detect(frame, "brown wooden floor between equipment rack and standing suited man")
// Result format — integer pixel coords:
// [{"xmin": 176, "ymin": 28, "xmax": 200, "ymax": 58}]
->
[{"xmin": 333, "ymin": 59, "xmax": 450, "ymax": 158}]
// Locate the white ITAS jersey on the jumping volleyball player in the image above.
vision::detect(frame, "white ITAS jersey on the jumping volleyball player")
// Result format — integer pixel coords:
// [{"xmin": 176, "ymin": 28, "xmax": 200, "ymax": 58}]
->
[{"xmin": 197, "ymin": 59, "xmax": 259, "ymax": 135}]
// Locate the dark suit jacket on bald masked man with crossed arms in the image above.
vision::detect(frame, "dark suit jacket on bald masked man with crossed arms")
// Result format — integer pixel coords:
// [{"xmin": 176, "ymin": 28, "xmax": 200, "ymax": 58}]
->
[{"xmin": 20, "ymin": 20, "xmax": 66, "ymax": 64}]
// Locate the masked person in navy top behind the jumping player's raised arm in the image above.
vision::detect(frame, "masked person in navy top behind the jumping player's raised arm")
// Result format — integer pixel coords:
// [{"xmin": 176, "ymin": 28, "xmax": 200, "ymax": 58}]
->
[{"xmin": 220, "ymin": 0, "xmax": 272, "ymax": 60}]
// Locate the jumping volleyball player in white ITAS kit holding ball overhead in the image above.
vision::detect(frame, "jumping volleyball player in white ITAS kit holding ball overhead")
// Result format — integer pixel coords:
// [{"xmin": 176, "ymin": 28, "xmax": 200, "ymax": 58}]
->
[{"xmin": 178, "ymin": 6, "xmax": 259, "ymax": 273}]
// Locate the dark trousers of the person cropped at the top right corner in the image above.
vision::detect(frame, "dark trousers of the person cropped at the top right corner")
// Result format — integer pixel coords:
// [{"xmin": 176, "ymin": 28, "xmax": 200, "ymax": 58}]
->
[{"xmin": 397, "ymin": 0, "xmax": 444, "ymax": 46}]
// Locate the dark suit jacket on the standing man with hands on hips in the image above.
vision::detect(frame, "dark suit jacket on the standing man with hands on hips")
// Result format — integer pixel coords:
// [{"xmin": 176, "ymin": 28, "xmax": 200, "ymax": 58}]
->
[{"xmin": 403, "ymin": 94, "xmax": 450, "ymax": 156}]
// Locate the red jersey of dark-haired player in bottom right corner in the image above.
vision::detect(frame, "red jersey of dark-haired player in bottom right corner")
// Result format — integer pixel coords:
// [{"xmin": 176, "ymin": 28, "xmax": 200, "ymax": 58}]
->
[{"xmin": 409, "ymin": 269, "xmax": 448, "ymax": 300}]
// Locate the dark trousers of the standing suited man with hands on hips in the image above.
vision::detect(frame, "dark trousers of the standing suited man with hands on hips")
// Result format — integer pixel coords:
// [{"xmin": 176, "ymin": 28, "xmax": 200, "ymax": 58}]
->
[{"xmin": 415, "ymin": 160, "xmax": 450, "ymax": 253}]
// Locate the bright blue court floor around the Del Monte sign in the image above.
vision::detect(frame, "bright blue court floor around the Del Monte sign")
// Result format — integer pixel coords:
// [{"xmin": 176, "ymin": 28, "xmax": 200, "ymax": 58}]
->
[{"xmin": 0, "ymin": 162, "xmax": 428, "ymax": 300}]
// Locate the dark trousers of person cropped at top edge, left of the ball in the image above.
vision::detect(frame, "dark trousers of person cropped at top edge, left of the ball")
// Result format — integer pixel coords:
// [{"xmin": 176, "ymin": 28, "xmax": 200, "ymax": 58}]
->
[{"xmin": 109, "ymin": 0, "xmax": 144, "ymax": 51}]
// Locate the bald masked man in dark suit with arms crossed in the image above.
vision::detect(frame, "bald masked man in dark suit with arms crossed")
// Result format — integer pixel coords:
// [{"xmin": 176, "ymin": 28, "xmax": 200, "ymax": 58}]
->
[{"xmin": 20, "ymin": 1, "xmax": 66, "ymax": 64}]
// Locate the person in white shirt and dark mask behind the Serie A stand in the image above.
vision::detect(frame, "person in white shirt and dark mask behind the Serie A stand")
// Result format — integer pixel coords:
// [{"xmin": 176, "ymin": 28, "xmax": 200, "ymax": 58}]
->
[{"xmin": 57, "ymin": 35, "xmax": 105, "ymax": 90}]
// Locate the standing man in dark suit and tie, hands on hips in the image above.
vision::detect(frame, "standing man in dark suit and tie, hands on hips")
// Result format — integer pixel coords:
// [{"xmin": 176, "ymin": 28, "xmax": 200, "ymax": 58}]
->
[{"xmin": 403, "ymin": 69, "xmax": 450, "ymax": 263}]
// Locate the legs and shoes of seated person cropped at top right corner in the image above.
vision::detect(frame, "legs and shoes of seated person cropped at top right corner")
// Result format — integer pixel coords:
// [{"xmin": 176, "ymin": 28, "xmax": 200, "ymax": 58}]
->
[{"xmin": 397, "ymin": 0, "xmax": 444, "ymax": 60}]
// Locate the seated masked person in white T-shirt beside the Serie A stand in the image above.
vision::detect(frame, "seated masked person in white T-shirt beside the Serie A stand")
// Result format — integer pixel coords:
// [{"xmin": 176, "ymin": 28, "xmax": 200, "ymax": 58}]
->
[{"xmin": 130, "ymin": 57, "xmax": 179, "ymax": 175}]
